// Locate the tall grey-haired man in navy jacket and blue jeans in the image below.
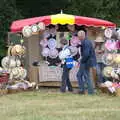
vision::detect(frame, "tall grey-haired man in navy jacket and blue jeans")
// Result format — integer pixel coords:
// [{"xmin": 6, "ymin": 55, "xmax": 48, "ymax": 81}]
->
[{"xmin": 77, "ymin": 30, "xmax": 96, "ymax": 94}]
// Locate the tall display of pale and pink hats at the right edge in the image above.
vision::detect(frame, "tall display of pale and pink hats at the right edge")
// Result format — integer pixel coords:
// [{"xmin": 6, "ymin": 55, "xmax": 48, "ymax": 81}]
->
[{"xmin": 102, "ymin": 28, "xmax": 120, "ymax": 83}]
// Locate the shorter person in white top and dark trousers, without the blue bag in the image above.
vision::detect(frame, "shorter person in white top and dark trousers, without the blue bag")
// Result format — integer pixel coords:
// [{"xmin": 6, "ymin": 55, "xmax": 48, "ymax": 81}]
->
[{"xmin": 59, "ymin": 38, "xmax": 73, "ymax": 93}]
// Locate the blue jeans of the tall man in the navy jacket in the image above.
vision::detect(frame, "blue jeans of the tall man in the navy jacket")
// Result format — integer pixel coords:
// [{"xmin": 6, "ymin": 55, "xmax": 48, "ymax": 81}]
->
[{"xmin": 77, "ymin": 64, "xmax": 94, "ymax": 94}]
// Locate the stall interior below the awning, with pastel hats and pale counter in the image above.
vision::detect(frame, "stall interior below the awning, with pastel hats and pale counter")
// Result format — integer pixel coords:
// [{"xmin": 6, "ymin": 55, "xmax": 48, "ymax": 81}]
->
[{"xmin": 24, "ymin": 24, "xmax": 104, "ymax": 86}]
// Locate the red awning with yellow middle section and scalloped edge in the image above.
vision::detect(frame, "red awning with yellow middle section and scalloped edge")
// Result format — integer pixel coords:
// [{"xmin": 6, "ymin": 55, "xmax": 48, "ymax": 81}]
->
[{"xmin": 10, "ymin": 14, "xmax": 116, "ymax": 32}]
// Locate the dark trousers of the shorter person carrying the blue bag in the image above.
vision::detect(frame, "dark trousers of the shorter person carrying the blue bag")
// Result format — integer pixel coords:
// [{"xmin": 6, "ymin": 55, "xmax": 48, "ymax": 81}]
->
[{"xmin": 60, "ymin": 65, "xmax": 72, "ymax": 92}]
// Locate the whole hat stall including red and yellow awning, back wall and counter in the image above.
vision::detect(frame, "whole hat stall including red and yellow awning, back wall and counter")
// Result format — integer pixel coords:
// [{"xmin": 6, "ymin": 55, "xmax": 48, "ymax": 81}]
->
[{"xmin": 10, "ymin": 13, "xmax": 116, "ymax": 86}]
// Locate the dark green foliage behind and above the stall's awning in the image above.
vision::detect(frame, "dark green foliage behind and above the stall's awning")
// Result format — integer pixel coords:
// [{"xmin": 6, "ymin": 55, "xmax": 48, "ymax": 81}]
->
[{"xmin": 0, "ymin": 0, "xmax": 120, "ymax": 56}]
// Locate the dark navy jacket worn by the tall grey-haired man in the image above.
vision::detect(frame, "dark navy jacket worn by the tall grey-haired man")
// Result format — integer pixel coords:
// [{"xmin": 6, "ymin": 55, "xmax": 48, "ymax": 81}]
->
[{"xmin": 81, "ymin": 39, "xmax": 97, "ymax": 67}]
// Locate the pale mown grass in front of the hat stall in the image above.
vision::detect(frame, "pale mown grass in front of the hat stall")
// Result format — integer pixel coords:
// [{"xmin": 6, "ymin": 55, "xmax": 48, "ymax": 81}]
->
[{"xmin": 0, "ymin": 89, "xmax": 120, "ymax": 120}]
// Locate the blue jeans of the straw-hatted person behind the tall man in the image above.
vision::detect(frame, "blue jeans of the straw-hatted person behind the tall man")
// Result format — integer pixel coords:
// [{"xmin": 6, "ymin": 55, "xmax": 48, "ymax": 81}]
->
[{"xmin": 96, "ymin": 63, "xmax": 105, "ymax": 83}]
